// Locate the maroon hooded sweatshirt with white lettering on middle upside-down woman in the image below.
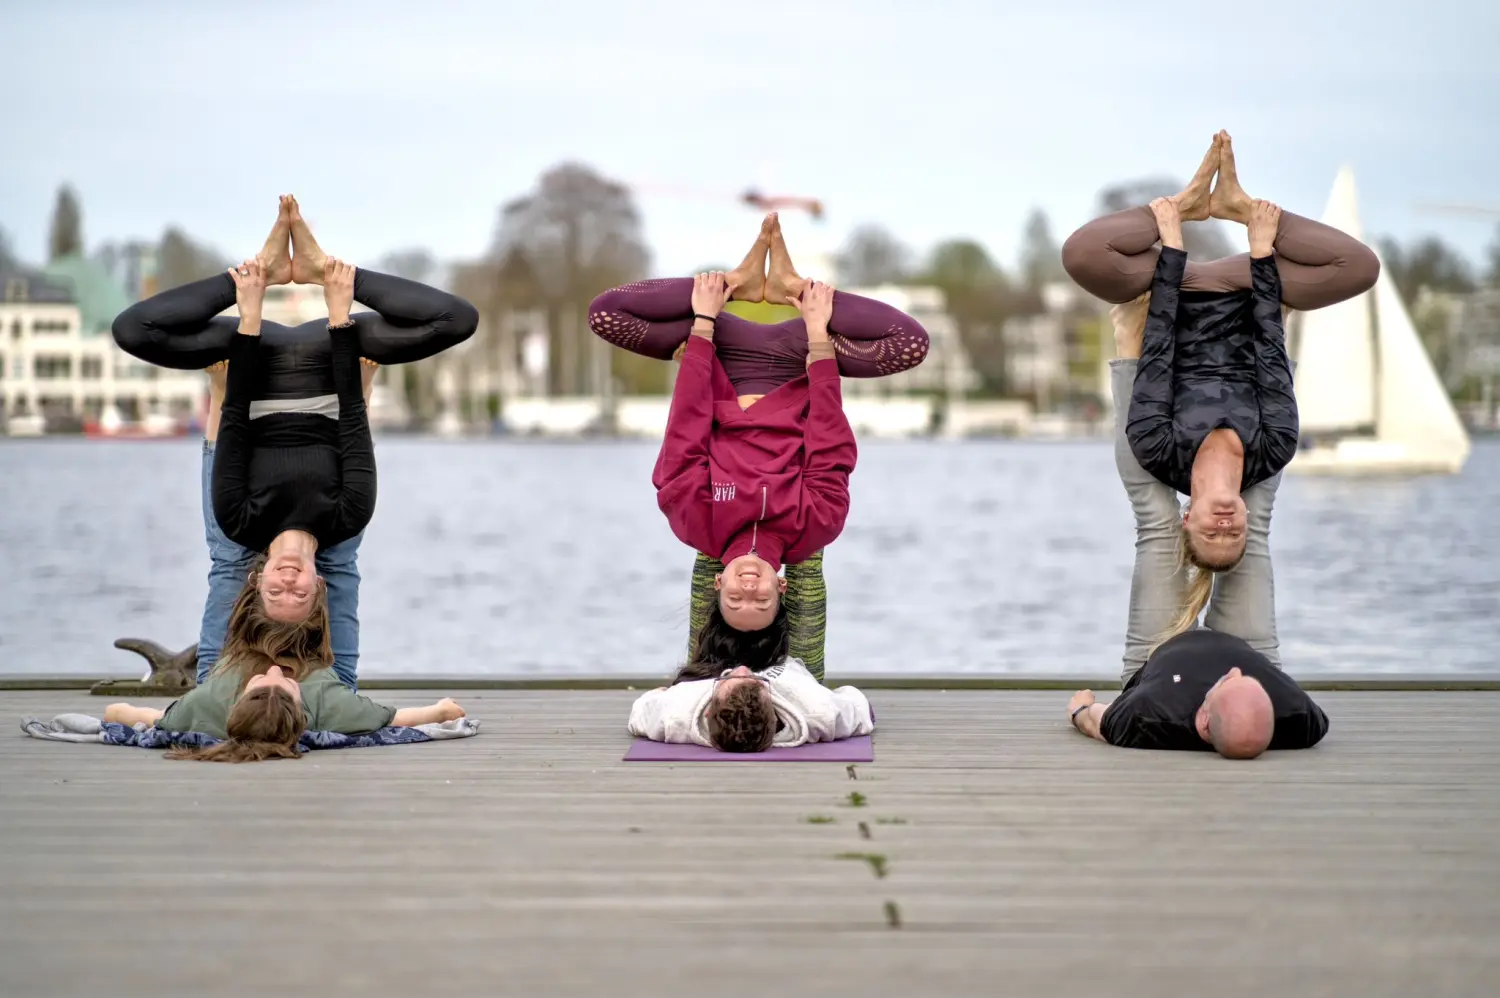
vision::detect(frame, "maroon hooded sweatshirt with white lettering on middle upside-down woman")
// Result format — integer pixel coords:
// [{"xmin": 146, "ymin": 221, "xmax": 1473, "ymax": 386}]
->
[{"xmin": 651, "ymin": 336, "xmax": 857, "ymax": 569}]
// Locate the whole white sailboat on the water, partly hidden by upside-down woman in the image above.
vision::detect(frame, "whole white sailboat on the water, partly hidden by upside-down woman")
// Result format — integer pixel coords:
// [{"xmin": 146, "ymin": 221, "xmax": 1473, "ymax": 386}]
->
[{"xmin": 1289, "ymin": 167, "xmax": 1470, "ymax": 476}]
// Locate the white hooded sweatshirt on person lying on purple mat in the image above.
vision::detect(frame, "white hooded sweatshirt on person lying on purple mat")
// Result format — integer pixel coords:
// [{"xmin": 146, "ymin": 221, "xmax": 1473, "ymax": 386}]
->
[{"xmin": 630, "ymin": 659, "xmax": 875, "ymax": 749}]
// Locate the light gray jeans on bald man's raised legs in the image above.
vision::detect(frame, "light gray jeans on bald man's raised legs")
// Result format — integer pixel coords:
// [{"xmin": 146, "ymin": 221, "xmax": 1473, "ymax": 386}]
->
[{"xmin": 1110, "ymin": 359, "xmax": 1281, "ymax": 680}]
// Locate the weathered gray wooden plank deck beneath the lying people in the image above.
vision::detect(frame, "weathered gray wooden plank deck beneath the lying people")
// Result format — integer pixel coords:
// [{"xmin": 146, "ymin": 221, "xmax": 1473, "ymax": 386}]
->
[{"xmin": 0, "ymin": 690, "xmax": 1500, "ymax": 998}]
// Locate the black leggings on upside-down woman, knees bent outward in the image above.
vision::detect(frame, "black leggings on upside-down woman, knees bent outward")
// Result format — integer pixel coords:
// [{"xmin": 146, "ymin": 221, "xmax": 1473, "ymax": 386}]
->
[{"xmin": 114, "ymin": 269, "xmax": 479, "ymax": 387}]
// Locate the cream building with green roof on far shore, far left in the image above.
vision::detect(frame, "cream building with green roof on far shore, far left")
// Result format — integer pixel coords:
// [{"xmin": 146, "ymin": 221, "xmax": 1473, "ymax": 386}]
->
[{"xmin": 0, "ymin": 257, "xmax": 206, "ymax": 428}]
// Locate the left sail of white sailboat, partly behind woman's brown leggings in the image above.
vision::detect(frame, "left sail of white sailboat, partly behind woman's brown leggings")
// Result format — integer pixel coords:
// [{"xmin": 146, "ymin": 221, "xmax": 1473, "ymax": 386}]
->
[{"xmin": 1295, "ymin": 167, "xmax": 1376, "ymax": 437}]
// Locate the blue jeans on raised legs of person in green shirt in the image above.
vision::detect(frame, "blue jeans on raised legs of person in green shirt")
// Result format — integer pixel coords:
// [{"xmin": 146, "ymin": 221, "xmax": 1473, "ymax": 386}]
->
[{"xmin": 198, "ymin": 440, "xmax": 365, "ymax": 690}]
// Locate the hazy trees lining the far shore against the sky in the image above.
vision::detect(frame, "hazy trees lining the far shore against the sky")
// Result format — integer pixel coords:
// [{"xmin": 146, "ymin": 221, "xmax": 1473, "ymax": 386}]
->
[{"xmin": 11, "ymin": 169, "xmax": 1500, "ymax": 396}]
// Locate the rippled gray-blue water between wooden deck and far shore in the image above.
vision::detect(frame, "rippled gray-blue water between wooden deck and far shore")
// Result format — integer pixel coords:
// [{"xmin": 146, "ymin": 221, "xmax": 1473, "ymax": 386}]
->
[{"xmin": 0, "ymin": 438, "xmax": 1500, "ymax": 677}]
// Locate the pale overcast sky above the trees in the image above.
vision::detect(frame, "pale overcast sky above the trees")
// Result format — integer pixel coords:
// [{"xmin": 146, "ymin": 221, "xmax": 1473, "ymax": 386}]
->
[{"xmin": 0, "ymin": 0, "xmax": 1500, "ymax": 273}]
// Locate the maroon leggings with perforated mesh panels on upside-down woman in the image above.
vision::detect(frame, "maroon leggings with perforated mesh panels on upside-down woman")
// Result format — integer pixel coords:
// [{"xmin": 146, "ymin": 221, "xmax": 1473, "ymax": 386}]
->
[{"xmin": 588, "ymin": 278, "xmax": 929, "ymax": 395}]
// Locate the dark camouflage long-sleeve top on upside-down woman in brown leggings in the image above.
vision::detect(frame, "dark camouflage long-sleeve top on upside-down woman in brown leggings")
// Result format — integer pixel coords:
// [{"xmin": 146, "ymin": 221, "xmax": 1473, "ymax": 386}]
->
[{"xmin": 1125, "ymin": 246, "xmax": 1298, "ymax": 494}]
